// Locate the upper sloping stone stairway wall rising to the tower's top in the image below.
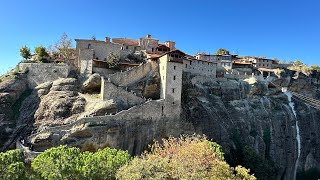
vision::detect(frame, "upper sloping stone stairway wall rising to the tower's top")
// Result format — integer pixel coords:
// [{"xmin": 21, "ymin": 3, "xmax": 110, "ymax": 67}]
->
[{"xmin": 109, "ymin": 61, "xmax": 158, "ymax": 86}]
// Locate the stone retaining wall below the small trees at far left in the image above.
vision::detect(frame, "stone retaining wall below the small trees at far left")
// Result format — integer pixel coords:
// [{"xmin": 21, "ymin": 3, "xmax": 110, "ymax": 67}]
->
[{"xmin": 19, "ymin": 63, "xmax": 72, "ymax": 88}]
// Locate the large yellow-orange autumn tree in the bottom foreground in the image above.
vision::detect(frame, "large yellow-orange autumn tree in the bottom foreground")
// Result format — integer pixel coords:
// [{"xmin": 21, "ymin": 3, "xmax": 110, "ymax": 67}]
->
[{"xmin": 117, "ymin": 135, "xmax": 255, "ymax": 180}]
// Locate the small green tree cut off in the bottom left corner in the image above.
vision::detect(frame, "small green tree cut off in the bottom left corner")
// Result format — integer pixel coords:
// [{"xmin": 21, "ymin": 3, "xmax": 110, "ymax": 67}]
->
[{"xmin": 0, "ymin": 150, "xmax": 27, "ymax": 180}]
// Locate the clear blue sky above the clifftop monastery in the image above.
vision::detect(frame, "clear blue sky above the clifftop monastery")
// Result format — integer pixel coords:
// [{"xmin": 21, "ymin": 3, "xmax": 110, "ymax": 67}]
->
[{"xmin": 0, "ymin": 0, "xmax": 320, "ymax": 74}]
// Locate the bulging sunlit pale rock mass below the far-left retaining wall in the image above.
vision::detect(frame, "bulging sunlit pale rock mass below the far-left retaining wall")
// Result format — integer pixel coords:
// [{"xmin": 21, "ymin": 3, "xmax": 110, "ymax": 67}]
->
[{"xmin": 35, "ymin": 78, "xmax": 86, "ymax": 127}]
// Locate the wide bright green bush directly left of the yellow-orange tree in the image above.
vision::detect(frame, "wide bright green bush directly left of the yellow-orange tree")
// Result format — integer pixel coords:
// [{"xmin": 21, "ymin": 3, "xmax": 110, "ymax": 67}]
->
[{"xmin": 31, "ymin": 146, "xmax": 130, "ymax": 180}]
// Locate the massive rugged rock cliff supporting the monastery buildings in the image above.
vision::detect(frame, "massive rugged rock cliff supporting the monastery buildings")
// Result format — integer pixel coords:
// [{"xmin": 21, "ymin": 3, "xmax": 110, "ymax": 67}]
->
[{"xmin": 0, "ymin": 65, "xmax": 320, "ymax": 179}]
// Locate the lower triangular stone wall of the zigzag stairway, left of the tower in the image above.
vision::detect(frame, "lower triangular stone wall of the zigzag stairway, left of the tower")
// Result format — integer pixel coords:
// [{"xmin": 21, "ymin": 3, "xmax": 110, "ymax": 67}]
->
[{"xmin": 101, "ymin": 78, "xmax": 145, "ymax": 110}]
